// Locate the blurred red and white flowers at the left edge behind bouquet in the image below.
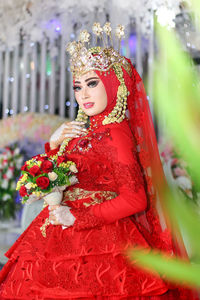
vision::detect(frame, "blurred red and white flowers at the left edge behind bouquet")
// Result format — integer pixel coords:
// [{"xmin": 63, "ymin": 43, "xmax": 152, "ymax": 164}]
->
[{"xmin": 0, "ymin": 145, "xmax": 23, "ymax": 219}]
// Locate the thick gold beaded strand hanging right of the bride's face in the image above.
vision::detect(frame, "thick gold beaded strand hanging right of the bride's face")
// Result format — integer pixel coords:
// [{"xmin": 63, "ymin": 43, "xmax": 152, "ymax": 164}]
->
[{"xmin": 102, "ymin": 64, "xmax": 129, "ymax": 125}]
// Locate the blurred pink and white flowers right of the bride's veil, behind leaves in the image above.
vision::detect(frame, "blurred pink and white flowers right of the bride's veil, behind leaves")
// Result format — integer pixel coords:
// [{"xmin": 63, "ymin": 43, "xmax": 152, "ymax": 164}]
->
[{"xmin": 161, "ymin": 143, "xmax": 199, "ymax": 200}]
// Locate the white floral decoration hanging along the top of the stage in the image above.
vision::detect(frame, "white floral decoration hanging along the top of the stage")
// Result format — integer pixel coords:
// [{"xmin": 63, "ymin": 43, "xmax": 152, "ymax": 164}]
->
[{"xmin": 0, "ymin": 0, "xmax": 191, "ymax": 49}]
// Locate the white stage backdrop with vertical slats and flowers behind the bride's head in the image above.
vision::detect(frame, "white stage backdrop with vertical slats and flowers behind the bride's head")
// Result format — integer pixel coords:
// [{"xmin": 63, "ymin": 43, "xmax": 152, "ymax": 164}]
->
[{"xmin": 0, "ymin": 0, "xmax": 197, "ymax": 119}]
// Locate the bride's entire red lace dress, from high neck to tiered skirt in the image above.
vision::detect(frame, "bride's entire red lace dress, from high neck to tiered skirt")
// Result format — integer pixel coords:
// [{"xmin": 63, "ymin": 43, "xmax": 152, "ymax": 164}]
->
[{"xmin": 0, "ymin": 115, "xmax": 197, "ymax": 300}]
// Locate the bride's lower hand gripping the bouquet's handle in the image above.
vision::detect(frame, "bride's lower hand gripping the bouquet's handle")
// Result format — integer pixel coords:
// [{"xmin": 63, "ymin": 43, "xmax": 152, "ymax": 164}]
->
[{"xmin": 49, "ymin": 205, "xmax": 76, "ymax": 227}]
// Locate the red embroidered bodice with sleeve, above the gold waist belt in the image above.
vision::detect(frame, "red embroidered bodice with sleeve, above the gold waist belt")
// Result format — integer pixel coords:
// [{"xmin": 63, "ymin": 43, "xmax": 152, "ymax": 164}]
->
[{"xmin": 46, "ymin": 114, "xmax": 146, "ymax": 226}]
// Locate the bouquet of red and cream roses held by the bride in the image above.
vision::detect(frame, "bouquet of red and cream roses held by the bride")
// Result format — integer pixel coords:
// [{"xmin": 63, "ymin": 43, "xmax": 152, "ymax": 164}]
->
[{"xmin": 16, "ymin": 154, "xmax": 78, "ymax": 204}]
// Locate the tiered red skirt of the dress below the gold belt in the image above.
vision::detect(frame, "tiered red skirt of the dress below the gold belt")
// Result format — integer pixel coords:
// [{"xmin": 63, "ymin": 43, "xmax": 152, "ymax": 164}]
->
[{"xmin": 0, "ymin": 207, "xmax": 196, "ymax": 300}]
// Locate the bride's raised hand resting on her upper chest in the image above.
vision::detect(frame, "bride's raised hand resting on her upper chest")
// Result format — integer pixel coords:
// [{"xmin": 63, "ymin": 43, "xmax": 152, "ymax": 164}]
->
[{"xmin": 50, "ymin": 121, "xmax": 87, "ymax": 149}]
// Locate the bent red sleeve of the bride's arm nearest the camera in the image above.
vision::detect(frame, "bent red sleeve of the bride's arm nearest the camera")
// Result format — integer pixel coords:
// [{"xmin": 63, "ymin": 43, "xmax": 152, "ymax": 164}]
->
[{"xmin": 72, "ymin": 125, "xmax": 147, "ymax": 230}]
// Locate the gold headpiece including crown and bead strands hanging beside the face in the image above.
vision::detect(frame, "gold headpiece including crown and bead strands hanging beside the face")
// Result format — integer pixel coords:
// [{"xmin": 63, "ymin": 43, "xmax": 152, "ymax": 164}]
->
[{"xmin": 61, "ymin": 22, "xmax": 132, "ymax": 132}]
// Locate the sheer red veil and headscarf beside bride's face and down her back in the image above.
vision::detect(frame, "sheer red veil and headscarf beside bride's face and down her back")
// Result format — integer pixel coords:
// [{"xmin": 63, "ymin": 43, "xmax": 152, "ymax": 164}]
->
[{"xmin": 96, "ymin": 59, "xmax": 186, "ymax": 256}]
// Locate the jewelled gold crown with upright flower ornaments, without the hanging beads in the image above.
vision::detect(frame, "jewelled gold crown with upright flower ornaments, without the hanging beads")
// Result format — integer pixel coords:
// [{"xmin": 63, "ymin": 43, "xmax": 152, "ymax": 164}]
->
[{"xmin": 66, "ymin": 22, "xmax": 131, "ymax": 77}]
